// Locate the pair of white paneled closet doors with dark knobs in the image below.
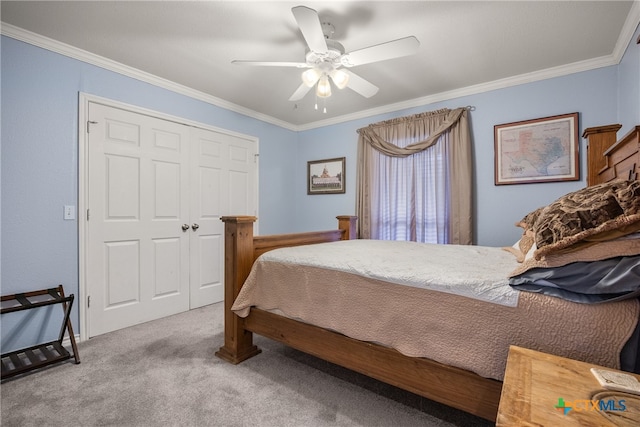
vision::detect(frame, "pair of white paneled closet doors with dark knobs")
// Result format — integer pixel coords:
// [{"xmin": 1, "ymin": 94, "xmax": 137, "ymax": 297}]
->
[{"xmin": 85, "ymin": 102, "xmax": 258, "ymax": 337}]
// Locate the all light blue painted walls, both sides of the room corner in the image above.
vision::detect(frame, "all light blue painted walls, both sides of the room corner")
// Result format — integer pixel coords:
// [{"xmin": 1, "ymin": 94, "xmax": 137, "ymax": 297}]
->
[{"xmin": 0, "ymin": 21, "xmax": 640, "ymax": 344}]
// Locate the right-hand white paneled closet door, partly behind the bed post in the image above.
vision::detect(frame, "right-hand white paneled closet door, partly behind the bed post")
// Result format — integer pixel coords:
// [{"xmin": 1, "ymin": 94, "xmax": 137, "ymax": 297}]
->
[{"xmin": 190, "ymin": 128, "xmax": 257, "ymax": 308}]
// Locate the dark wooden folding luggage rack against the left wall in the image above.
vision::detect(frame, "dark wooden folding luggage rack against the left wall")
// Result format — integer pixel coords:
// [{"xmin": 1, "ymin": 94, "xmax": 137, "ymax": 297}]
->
[{"xmin": 0, "ymin": 285, "xmax": 80, "ymax": 379}]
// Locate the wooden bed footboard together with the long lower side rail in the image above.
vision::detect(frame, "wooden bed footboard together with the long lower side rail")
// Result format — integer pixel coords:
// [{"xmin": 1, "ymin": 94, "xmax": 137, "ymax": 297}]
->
[{"xmin": 216, "ymin": 216, "xmax": 502, "ymax": 421}]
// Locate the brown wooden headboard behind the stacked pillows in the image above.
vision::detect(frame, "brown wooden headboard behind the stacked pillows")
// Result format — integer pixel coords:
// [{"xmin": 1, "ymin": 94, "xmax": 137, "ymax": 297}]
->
[{"xmin": 582, "ymin": 124, "xmax": 640, "ymax": 185}]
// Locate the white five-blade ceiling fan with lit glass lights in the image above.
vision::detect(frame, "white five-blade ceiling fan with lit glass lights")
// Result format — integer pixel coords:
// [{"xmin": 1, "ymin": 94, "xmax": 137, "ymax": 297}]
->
[{"xmin": 232, "ymin": 6, "xmax": 420, "ymax": 101}]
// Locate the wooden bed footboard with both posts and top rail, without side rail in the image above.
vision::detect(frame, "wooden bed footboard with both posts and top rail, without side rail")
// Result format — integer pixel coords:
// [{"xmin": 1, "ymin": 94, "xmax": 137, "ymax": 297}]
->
[{"xmin": 216, "ymin": 215, "xmax": 357, "ymax": 364}]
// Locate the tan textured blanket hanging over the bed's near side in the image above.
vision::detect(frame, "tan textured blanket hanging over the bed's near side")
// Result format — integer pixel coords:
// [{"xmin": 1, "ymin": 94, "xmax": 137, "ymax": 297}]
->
[{"xmin": 232, "ymin": 252, "xmax": 640, "ymax": 380}]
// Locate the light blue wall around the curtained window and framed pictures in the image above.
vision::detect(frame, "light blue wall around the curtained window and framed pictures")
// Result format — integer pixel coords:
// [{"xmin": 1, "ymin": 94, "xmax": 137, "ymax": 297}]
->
[{"xmin": 296, "ymin": 22, "xmax": 640, "ymax": 246}]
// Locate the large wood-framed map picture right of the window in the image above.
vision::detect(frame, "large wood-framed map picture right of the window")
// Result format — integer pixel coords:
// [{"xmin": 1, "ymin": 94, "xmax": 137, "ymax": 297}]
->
[{"xmin": 493, "ymin": 113, "xmax": 580, "ymax": 185}]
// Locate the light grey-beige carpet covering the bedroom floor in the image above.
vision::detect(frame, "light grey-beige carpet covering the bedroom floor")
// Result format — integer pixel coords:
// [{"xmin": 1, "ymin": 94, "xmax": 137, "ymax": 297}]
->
[{"xmin": 0, "ymin": 303, "xmax": 491, "ymax": 427}]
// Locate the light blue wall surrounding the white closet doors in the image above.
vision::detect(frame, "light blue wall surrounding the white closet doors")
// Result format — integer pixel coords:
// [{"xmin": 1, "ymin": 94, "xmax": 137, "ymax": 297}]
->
[{"xmin": 1, "ymin": 37, "xmax": 297, "ymax": 344}]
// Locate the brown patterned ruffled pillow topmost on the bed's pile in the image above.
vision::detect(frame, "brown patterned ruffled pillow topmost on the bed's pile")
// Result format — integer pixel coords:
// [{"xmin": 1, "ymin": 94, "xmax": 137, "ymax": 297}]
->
[{"xmin": 532, "ymin": 180, "xmax": 640, "ymax": 259}]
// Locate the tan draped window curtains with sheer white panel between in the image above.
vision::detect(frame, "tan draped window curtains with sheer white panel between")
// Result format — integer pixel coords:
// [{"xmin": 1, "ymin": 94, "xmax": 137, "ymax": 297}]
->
[{"xmin": 356, "ymin": 108, "xmax": 473, "ymax": 244}]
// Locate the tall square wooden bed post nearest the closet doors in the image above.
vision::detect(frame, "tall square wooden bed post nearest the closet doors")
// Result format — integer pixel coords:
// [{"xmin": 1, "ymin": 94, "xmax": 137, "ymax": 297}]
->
[{"xmin": 216, "ymin": 216, "xmax": 262, "ymax": 365}]
